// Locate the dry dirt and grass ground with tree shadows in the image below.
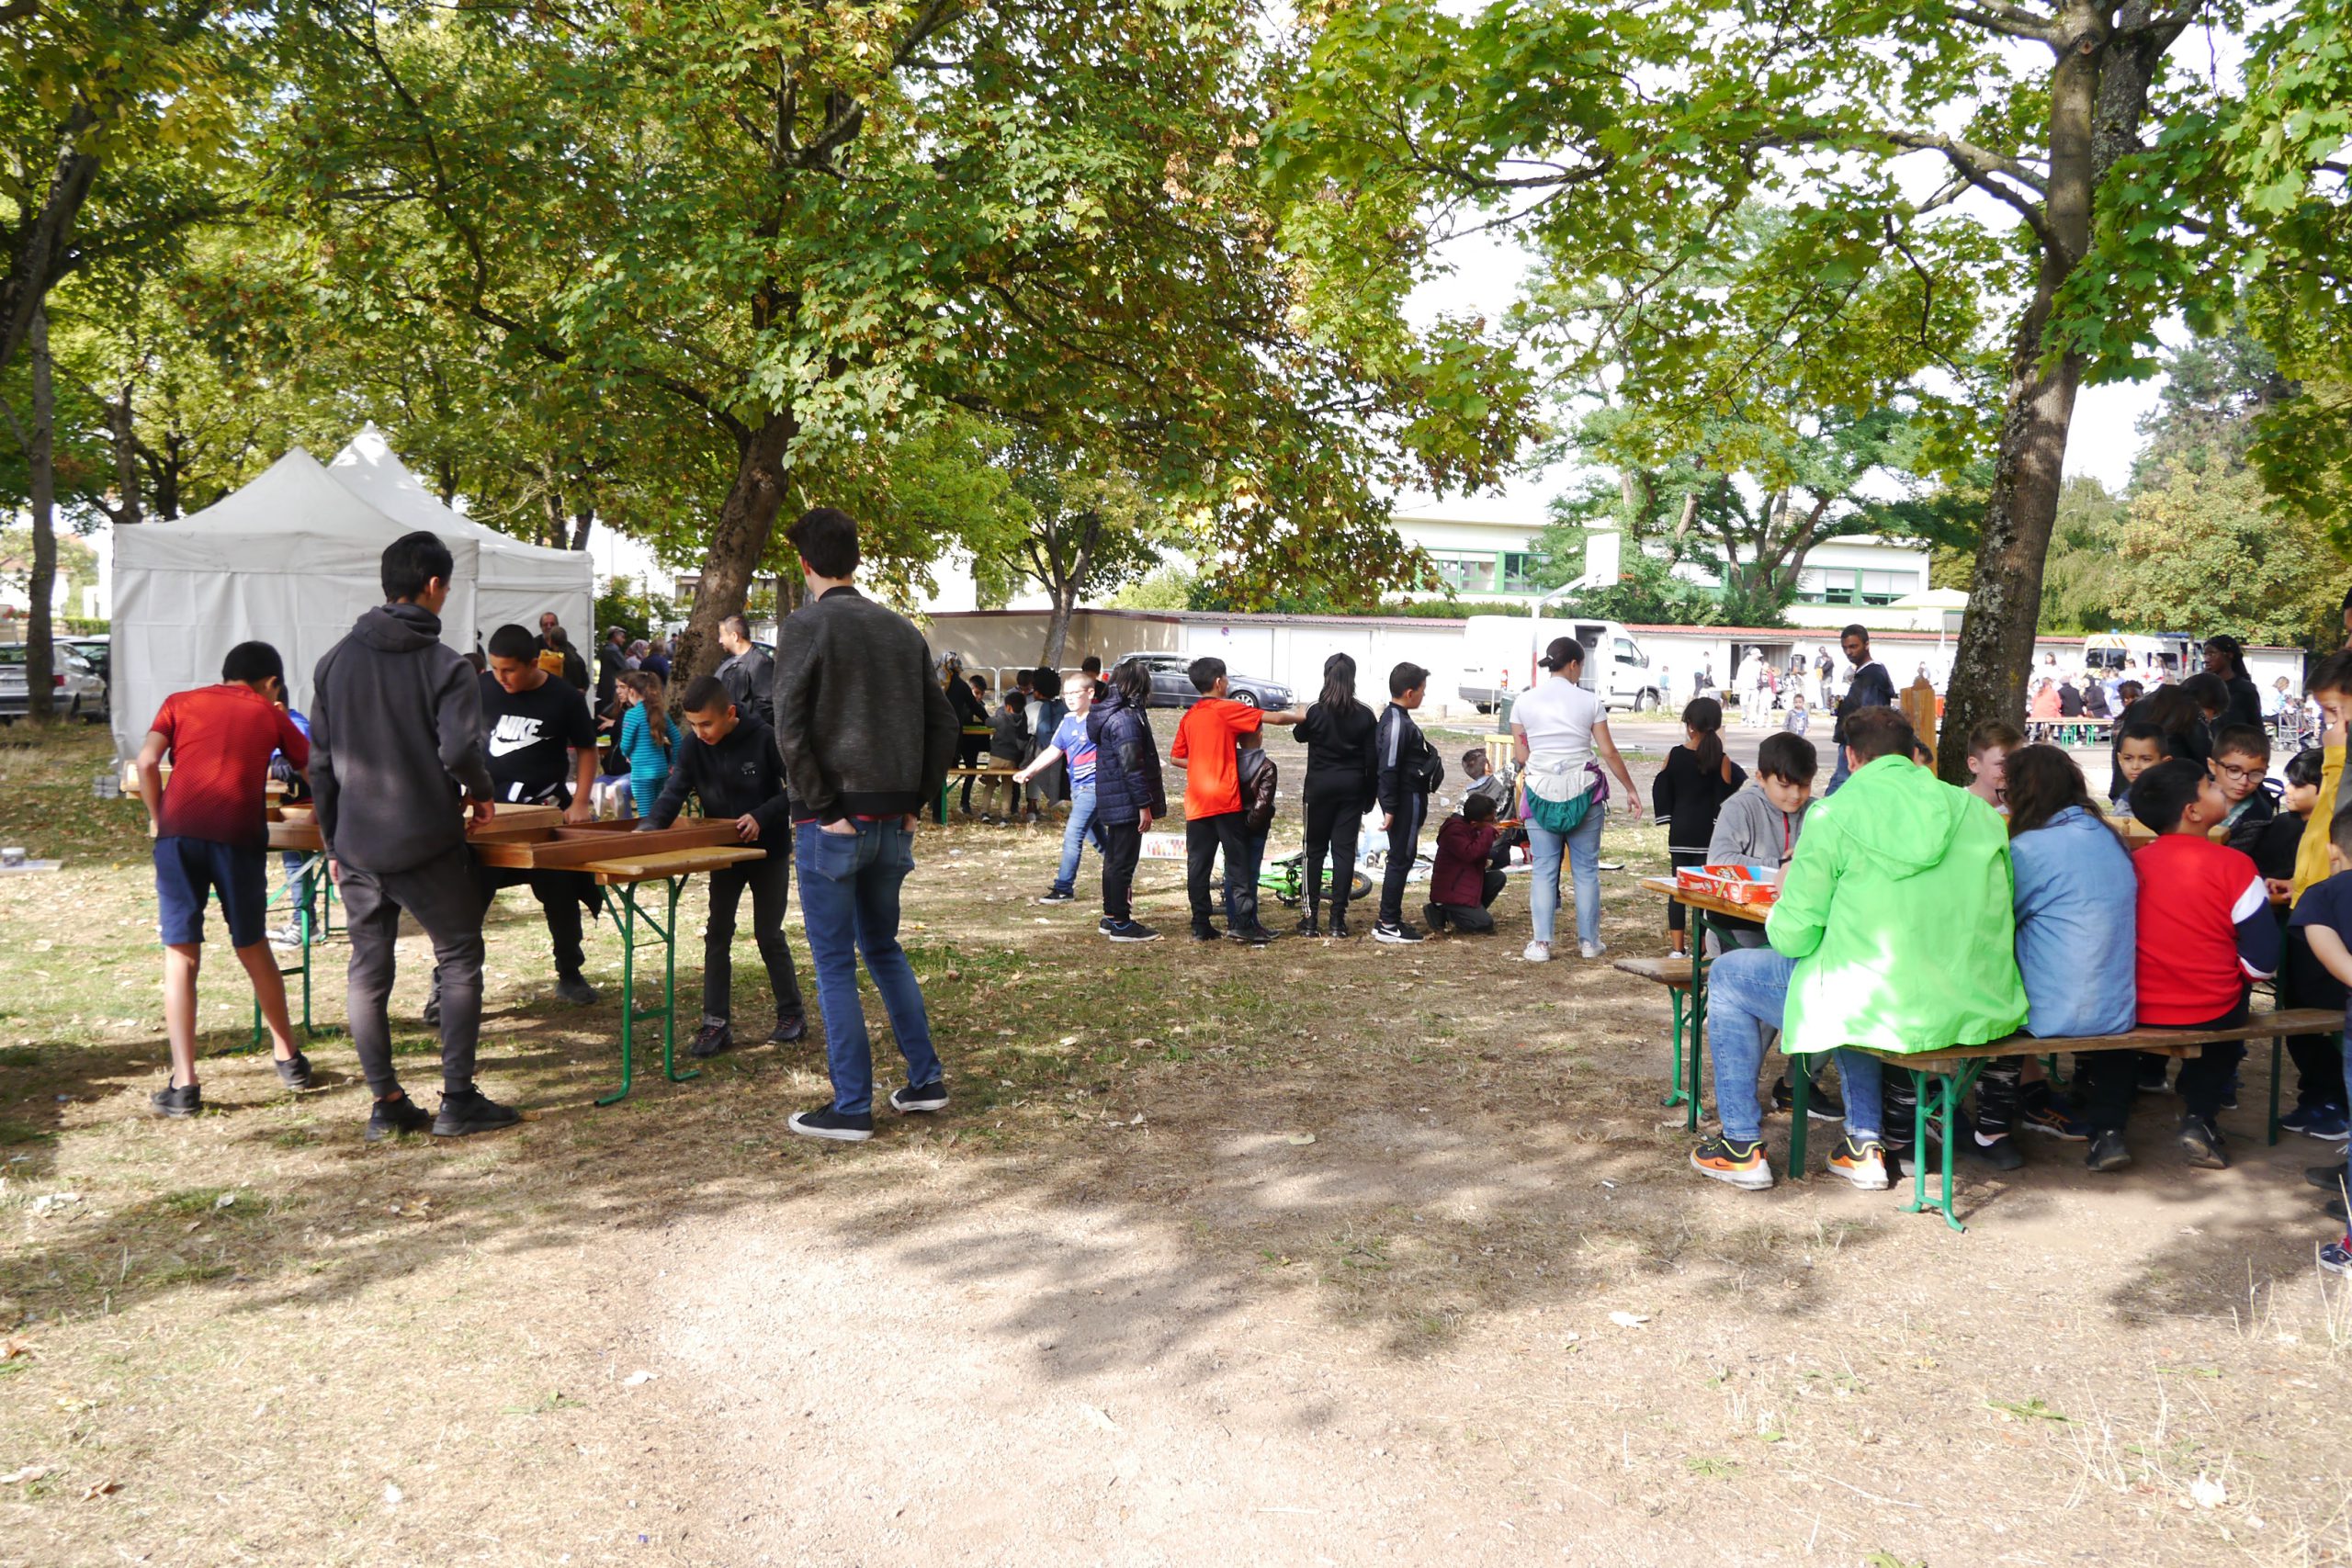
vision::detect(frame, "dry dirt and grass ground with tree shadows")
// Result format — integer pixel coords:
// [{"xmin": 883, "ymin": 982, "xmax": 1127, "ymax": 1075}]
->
[{"xmin": 0, "ymin": 715, "xmax": 2352, "ymax": 1568}]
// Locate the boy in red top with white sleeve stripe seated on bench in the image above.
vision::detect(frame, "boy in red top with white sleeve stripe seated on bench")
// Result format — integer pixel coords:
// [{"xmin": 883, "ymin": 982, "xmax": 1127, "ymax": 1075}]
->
[{"xmin": 2076, "ymin": 760, "xmax": 2279, "ymax": 1170}]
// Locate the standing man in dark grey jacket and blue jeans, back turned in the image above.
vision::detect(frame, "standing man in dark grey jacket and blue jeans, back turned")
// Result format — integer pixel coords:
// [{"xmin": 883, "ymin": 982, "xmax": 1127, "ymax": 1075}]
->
[{"xmin": 755, "ymin": 505, "xmax": 957, "ymax": 1143}]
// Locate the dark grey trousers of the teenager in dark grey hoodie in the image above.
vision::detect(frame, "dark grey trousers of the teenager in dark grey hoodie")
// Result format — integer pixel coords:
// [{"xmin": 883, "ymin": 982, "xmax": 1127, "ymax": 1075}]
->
[{"xmin": 341, "ymin": 844, "xmax": 482, "ymax": 1100}]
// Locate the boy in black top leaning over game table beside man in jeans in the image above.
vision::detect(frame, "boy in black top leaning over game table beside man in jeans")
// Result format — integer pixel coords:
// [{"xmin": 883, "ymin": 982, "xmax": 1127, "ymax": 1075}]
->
[{"xmin": 638, "ymin": 674, "xmax": 809, "ymax": 1058}]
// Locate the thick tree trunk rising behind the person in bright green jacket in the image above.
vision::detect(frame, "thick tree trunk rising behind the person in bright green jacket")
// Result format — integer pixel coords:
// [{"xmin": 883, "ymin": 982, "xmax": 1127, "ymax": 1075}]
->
[{"xmin": 1936, "ymin": 0, "xmax": 2107, "ymax": 785}]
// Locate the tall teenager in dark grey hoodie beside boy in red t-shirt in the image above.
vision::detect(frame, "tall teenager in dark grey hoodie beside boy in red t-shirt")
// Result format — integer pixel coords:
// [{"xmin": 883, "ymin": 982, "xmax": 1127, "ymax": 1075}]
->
[{"xmin": 311, "ymin": 531, "xmax": 520, "ymax": 1140}]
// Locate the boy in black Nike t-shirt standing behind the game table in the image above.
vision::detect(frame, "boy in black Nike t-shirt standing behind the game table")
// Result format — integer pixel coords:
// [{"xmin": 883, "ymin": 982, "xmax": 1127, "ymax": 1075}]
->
[{"xmin": 475, "ymin": 626, "xmax": 605, "ymax": 1006}]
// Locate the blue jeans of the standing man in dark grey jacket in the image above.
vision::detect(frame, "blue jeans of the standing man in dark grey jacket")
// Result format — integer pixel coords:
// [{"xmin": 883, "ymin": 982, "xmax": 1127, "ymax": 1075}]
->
[{"xmin": 793, "ymin": 818, "xmax": 941, "ymax": 1117}]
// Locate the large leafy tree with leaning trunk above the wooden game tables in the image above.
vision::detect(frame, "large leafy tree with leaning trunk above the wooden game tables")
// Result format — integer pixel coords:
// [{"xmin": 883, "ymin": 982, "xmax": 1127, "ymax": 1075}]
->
[{"xmin": 273, "ymin": 0, "xmax": 1524, "ymax": 686}]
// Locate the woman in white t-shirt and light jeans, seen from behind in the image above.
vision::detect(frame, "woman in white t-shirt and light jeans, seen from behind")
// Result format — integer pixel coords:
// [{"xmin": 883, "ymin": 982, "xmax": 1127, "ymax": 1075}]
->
[{"xmin": 1510, "ymin": 637, "xmax": 1642, "ymax": 964}]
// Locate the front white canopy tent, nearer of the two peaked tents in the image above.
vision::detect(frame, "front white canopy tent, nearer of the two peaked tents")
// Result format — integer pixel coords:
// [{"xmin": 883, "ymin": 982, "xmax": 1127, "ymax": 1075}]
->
[{"xmin": 108, "ymin": 446, "xmax": 482, "ymax": 757}]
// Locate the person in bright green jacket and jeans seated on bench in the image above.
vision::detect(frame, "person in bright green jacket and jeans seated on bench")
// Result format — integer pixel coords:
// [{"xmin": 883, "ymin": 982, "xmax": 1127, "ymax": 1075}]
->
[{"xmin": 1691, "ymin": 707, "xmax": 2025, "ymax": 1190}]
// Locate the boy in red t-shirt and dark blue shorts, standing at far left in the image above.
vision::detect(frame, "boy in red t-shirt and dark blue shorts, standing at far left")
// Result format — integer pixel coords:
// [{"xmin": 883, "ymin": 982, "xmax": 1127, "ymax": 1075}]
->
[{"xmin": 139, "ymin": 642, "xmax": 311, "ymax": 1117}]
